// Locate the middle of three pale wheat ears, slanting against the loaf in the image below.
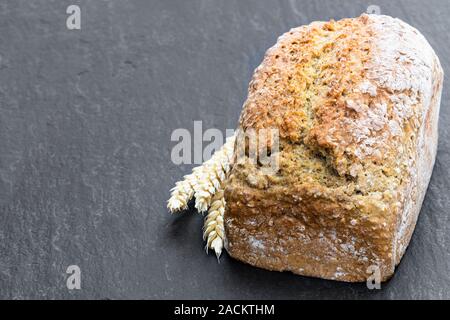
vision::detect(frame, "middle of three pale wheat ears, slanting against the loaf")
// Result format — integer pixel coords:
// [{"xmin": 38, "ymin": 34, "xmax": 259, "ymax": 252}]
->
[{"xmin": 194, "ymin": 136, "xmax": 235, "ymax": 213}]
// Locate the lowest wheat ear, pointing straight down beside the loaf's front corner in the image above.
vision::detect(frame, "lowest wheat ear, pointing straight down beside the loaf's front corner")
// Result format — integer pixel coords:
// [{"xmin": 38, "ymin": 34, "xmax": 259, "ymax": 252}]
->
[{"xmin": 203, "ymin": 189, "xmax": 225, "ymax": 259}]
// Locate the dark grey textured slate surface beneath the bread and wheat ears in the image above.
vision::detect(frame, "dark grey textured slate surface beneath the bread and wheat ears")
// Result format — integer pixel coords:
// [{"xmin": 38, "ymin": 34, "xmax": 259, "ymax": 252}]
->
[{"xmin": 0, "ymin": 0, "xmax": 450, "ymax": 299}]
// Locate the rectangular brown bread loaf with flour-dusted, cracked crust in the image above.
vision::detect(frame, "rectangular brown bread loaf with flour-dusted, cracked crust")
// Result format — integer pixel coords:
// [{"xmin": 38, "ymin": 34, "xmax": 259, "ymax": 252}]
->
[{"xmin": 224, "ymin": 15, "xmax": 443, "ymax": 282}]
